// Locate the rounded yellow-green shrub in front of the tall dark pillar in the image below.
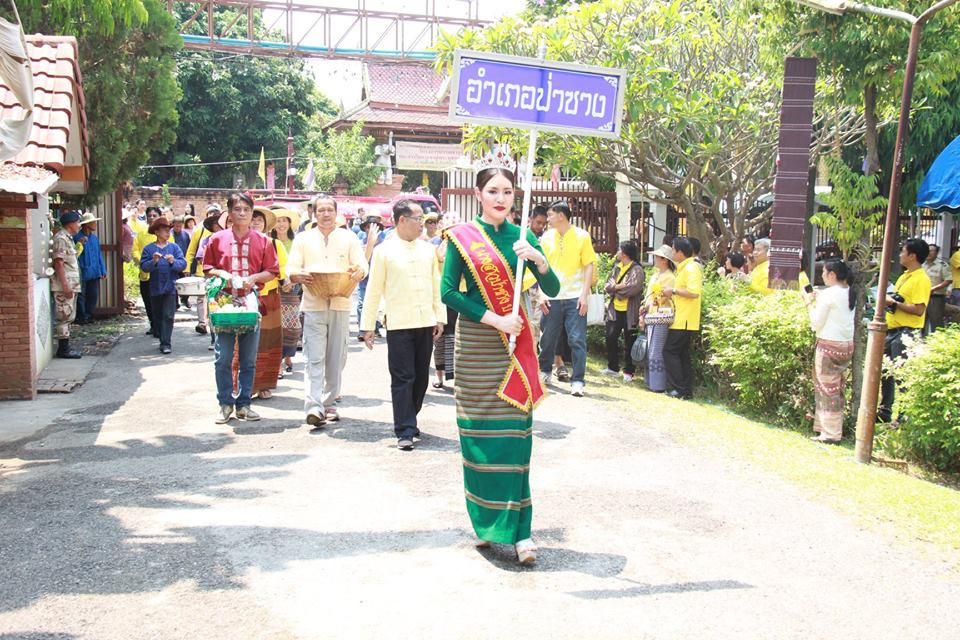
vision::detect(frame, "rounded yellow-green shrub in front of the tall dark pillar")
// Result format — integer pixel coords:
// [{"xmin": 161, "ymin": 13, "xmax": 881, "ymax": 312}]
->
[{"xmin": 703, "ymin": 283, "xmax": 814, "ymax": 427}]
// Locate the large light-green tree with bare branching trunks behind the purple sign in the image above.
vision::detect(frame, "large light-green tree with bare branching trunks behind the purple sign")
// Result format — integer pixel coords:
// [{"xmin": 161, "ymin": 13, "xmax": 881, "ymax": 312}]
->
[{"xmin": 437, "ymin": 0, "xmax": 859, "ymax": 255}]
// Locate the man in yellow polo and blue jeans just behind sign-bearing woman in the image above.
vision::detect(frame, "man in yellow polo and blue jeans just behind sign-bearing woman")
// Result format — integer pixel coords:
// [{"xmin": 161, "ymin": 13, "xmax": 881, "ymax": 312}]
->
[{"xmin": 540, "ymin": 202, "xmax": 597, "ymax": 397}]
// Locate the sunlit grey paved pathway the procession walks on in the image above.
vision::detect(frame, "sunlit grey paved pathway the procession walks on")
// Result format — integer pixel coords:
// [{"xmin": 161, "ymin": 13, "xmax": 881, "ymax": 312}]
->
[{"xmin": 0, "ymin": 318, "xmax": 960, "ymax": 640}]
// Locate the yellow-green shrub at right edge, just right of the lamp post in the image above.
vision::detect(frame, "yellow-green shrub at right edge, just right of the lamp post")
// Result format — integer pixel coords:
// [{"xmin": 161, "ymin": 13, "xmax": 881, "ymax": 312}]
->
[{"xmin": 880, "ymin": 325, "xmax": 960, "ymax": 471}]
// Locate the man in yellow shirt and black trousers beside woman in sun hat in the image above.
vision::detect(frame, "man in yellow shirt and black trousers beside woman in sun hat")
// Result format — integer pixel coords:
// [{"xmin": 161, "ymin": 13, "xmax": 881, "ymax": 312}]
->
[{"xmin": 663, "ymin": 237, "xmax": 703, "ymax": 400}]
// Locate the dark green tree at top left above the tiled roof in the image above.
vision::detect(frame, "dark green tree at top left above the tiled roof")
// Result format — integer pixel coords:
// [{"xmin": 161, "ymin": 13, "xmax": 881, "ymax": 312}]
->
[{"xmin": 7, "ymin": 0, "xmax": 182, "ymax": 201}]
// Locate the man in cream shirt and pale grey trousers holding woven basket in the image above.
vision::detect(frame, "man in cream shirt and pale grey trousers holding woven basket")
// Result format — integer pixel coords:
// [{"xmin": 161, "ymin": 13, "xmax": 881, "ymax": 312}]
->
[{"xmin": 287, "ymin": 196, "xmax": 367, "ymax": 427}]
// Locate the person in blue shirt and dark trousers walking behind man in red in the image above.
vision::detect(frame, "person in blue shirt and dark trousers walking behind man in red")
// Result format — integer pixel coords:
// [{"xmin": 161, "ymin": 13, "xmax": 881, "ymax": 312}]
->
[{"xmin": 140, "ymin": 216, "xmax": 187, "ymax": 353}]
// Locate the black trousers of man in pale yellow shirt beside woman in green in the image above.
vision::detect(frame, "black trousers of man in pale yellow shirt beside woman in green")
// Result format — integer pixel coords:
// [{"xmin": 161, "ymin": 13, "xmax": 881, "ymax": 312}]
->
[{"xmin": 387, "ymin": 327, "xmax": 433, "ymax": 438}]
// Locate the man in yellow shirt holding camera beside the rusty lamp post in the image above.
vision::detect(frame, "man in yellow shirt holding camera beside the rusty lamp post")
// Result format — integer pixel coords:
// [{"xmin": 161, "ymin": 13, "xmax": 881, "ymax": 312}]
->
[{"xmin": 877, "ymin": 238, "xmax": 930, "ymax": 422}]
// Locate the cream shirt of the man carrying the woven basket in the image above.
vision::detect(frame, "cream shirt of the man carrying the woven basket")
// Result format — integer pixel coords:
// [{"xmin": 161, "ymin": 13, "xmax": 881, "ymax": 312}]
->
[{"xmin": 287, "ymin": 227, "xmax": 367, "ymax": 311}]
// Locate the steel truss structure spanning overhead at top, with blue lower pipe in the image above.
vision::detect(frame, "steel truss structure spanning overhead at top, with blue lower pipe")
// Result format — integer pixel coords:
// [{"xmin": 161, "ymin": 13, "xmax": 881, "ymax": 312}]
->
[{"xmin": 167, "ymin": 0, "xmax": 490, "ymax": 62}]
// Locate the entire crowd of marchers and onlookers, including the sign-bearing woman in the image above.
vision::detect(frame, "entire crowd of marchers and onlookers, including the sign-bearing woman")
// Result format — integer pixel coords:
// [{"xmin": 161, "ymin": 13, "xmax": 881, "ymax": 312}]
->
[{"xmin": 52, "ymin": 157, "xmax": 960, "ymax": 563}]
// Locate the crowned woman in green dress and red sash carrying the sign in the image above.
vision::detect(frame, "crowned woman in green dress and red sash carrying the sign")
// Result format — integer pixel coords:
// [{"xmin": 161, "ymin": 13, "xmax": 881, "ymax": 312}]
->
[{"xmin": 441, "ymin": 166, "xmax": 560, "ymax": 564}]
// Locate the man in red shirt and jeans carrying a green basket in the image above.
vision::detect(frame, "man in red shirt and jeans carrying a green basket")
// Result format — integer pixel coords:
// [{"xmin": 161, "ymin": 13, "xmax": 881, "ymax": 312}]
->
[{"xmin": 203, "ymin": 193, "xmax": 280, "ymax": 424}]
